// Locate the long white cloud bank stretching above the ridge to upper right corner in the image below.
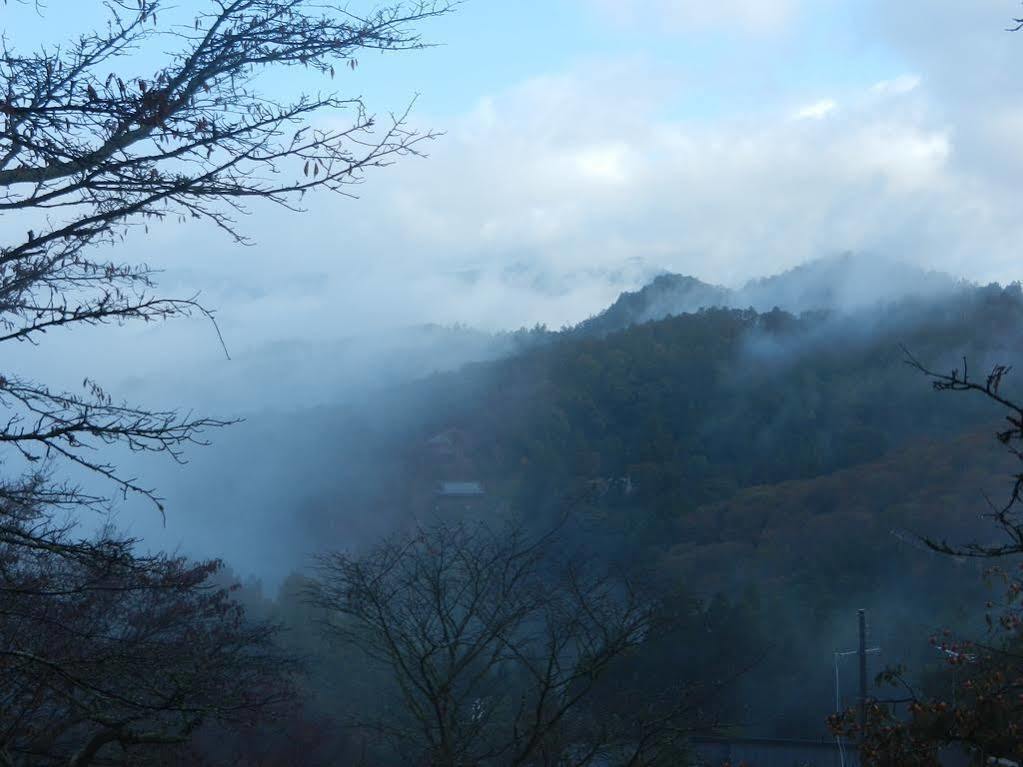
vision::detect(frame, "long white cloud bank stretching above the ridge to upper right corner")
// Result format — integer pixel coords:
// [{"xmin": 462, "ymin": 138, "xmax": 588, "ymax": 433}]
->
[{"xmin": 19, "ymin": 0, "xmax": 1023, "ymax": 402}]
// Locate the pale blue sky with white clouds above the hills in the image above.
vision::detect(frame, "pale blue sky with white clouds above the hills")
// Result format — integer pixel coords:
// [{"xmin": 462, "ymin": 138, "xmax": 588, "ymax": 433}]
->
[{"xmin": 6, "ymin": 0, "xmax": 1023, "ymax": 564}]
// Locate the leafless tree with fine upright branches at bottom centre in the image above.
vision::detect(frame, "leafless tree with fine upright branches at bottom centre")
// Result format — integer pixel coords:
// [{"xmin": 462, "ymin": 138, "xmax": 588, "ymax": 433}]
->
[{"xmin": 309, "ymin": 524, "xmax": 699, "ymax": 767}]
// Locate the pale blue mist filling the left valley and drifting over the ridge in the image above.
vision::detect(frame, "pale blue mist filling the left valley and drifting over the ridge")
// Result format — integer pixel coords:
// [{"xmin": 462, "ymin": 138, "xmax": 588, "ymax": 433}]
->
[{"xmin": 61, "ymin": 254, "xmax": 999, "ymax": 591}]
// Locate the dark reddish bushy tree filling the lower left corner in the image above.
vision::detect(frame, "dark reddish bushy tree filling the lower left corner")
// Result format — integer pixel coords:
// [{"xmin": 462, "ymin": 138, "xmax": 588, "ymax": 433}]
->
[{"xmin": 0, "ymin": 478, "xmax": 296, "ymax": 767}]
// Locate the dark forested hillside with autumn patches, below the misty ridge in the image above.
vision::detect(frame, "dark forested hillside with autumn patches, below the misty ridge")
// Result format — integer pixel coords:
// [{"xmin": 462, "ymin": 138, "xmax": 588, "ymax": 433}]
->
[{"xmin": 195, "ymin": 276, "xmax": 1023, "ymax": 752}]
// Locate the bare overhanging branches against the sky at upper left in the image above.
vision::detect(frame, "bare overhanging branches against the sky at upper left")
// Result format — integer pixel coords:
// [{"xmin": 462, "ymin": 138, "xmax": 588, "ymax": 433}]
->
[{"xmin": 0, "ymin": 0, "xmax": 450, "ymax": 511}]
